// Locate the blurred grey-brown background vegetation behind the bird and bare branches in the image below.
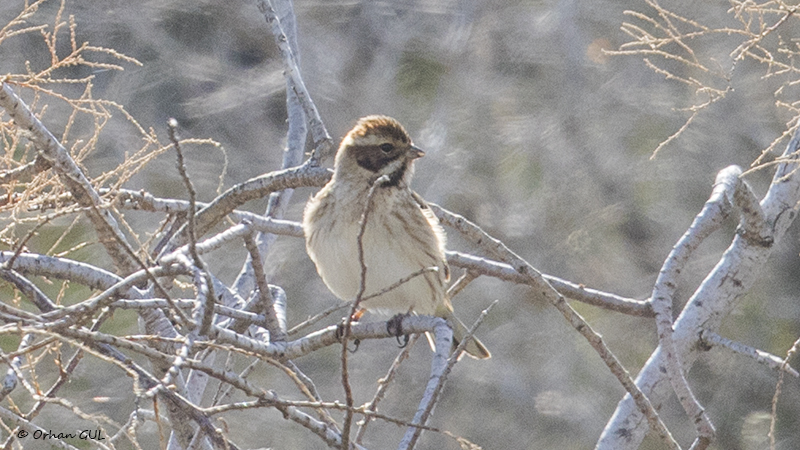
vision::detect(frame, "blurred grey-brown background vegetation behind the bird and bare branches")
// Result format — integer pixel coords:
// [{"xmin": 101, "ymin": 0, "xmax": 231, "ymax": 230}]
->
[{"xmin": 0, "ymin": 0, "xmax": 800, "ymax": 450}]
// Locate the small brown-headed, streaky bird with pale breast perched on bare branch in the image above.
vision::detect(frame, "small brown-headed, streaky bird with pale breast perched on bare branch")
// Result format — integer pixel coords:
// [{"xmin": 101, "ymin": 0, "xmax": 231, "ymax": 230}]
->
[{"xmin": 303, "ymin": 115, "xmax": 491, "ymax": 359}]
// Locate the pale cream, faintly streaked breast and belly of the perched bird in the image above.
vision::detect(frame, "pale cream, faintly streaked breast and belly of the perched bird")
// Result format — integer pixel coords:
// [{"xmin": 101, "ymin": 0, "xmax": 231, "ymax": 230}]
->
[{"xmin": 303, "ymin": 183, "xmax": 447, "ymax": 314}]
